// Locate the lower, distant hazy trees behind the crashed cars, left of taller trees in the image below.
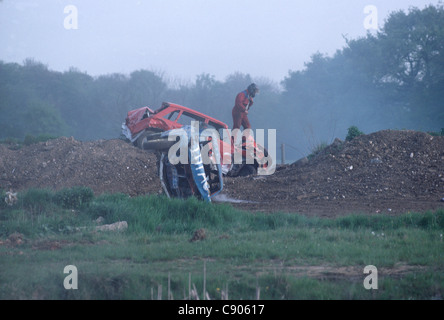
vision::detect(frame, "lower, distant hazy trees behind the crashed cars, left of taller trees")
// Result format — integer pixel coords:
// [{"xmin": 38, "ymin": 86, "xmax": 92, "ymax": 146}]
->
[{"xmin": 0, "ymin": 59, "xmax": 279, "ymax": 144}]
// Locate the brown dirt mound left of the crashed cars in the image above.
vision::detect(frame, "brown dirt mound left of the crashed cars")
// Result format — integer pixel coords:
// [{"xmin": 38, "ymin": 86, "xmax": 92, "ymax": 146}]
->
[{"xmin": 0, "ymin": 138, "xmax": 161, "ymax": 195}]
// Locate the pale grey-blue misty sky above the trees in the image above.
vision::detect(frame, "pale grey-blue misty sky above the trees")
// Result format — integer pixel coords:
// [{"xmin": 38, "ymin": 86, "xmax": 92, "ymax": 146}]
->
[{"xmin": 0, "ymin": 0, "xmax": 439, "ymax": 82}]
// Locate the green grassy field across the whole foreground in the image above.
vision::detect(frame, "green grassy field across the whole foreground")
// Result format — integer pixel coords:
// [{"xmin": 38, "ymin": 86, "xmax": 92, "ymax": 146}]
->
[{"xmin": 0, "ymin": 188, "xmax": 444, "ymax": 299}]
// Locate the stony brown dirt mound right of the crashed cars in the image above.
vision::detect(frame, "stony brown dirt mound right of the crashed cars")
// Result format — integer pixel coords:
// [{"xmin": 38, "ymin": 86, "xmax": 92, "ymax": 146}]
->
[{"xmin": 227, "ymin": 130, "xmax": 444, "ymax": 215}]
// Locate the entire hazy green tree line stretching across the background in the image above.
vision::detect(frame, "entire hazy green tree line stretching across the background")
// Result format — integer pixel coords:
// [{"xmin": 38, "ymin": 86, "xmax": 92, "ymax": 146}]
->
[{"xmin": 0, "ymin": 5, "xmax": 444, "ymax": 157}]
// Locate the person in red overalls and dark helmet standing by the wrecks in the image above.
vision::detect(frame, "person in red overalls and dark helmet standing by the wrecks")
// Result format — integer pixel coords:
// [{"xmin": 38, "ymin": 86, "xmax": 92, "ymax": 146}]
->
[{"xmin": 231, "ymin": 83, "xmax": 259, "ymax": 130}]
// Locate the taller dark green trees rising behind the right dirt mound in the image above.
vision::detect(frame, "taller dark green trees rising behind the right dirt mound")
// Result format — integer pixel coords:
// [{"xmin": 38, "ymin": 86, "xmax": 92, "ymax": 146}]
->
[{"xmin": 277, "ymin": 4, "xmax": 444, "ymax": 159}]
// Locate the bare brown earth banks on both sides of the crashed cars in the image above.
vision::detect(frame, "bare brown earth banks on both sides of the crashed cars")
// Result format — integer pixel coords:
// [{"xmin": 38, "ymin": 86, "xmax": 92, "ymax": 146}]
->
[{"xmin": 0, "ymin": 130, "xmax": 444, "ymax": 217}]
